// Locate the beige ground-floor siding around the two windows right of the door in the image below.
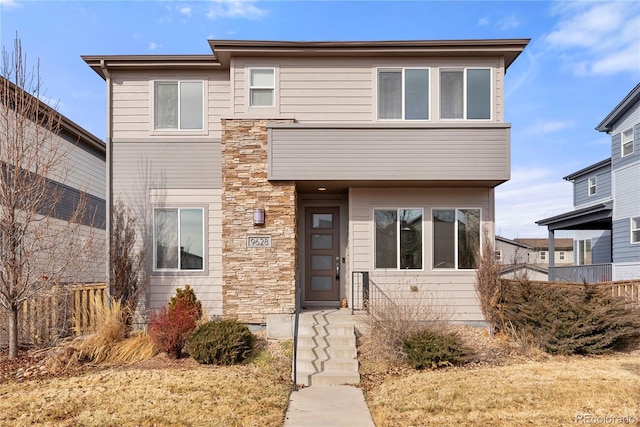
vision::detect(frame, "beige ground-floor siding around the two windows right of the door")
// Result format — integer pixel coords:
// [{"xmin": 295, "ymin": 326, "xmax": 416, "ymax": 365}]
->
[{"xmin": 348, "ymin": 188, "xmax": 494, "ymax": 322}]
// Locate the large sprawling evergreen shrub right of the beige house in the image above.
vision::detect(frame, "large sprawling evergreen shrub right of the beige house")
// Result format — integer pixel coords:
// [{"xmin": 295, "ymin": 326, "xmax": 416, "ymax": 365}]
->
[{"xmin": 500, "ymin": 280, "xmax": 640, "ymax": 355}]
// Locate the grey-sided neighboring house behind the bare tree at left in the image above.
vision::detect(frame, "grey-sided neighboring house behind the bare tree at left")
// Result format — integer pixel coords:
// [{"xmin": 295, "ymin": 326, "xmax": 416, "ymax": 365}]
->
[{"xmin": 0, "ymin": 76, "xmax": 106, "ymax": 283}]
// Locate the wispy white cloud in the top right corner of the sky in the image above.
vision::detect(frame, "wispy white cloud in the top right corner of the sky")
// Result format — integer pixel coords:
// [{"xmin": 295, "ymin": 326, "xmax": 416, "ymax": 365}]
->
[{"xmin": 544, "ymin": 1, "xmax": 640, "ymax": 76}]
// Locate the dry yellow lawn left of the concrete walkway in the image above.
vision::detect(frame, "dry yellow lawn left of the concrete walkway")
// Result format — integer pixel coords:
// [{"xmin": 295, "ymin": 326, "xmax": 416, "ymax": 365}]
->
[{"xmin": 0, "ymin": 343, "xmax": 291, "ymax": 427}]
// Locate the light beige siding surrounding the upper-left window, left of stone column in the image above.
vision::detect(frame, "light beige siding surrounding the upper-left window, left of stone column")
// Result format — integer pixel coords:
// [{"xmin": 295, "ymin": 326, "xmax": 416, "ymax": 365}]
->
[{"xmin": 112, "ymin": 70, "xmax": 231, "ymax": 139}]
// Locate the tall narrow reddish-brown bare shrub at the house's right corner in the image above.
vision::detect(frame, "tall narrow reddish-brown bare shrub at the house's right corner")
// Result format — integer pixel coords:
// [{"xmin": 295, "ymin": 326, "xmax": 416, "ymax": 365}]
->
[{"xmin": 475, "ymin": 233, "xmax": 502, "ymax": 335}]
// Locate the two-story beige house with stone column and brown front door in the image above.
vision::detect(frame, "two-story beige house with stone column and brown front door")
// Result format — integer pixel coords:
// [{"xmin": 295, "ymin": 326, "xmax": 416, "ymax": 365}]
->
[{"xmin": 83, "ymin": 40, "xmax": 528, "ymax": 323}]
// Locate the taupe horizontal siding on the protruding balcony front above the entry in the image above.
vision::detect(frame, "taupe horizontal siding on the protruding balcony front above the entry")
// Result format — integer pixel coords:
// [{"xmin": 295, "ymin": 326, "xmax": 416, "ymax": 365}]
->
[{"xmin": 269, "ymin": 124, "xmax": 510, "ymax": 181}]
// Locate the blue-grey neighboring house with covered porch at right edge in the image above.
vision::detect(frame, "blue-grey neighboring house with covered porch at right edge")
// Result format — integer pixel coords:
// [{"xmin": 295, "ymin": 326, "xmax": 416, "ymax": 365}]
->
[{"xmin": 537, "ymin": 84, "xmax": 640, "ymax": 282}]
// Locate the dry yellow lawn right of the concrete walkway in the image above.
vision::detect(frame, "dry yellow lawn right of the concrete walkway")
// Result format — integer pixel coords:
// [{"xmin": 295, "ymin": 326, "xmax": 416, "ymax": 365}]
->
[{"xmin": 361, "ymin": 330, "xmax": 640, "ymax": 427}]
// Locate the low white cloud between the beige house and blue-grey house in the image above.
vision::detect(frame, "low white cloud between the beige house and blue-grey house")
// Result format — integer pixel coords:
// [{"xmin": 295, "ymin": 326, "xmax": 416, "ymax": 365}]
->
[{"xmin": 496, "ymin": 167, "xmax": 573, "ymax": 239}]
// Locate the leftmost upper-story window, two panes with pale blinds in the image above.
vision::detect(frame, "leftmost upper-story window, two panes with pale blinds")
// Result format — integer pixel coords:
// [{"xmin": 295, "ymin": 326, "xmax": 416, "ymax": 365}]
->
[{"xmin": 154, "ymin": 81, "xmax": 204, "ymax": 130}]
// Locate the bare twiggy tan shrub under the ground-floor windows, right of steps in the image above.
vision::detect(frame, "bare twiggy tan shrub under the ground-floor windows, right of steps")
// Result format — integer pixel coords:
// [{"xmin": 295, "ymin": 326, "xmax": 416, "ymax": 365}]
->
[{"xmin": 371, "ymin": 288, "xmax": 451, "ymax": 362}]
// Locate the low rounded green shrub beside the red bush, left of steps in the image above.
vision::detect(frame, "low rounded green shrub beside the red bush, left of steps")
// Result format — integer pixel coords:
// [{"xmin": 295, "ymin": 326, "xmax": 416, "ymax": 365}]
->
[{"xmin": 187, "ymin": 320, "xmax": 254, "ymax": 365}]
